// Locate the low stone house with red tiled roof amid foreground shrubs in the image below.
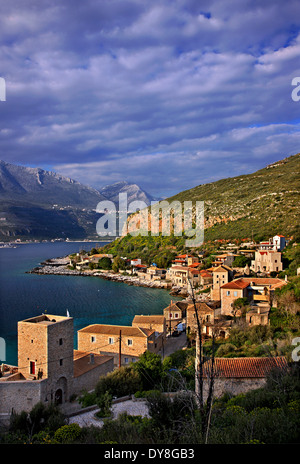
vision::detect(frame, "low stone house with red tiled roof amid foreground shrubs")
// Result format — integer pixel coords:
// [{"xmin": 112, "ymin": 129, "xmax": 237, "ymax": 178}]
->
[{"xmin": 204, "ymin": 356, "xmax": 288, "ymax": 397}]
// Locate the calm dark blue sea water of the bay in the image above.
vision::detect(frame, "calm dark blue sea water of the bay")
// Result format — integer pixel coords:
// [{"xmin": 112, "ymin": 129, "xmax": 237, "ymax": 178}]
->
[{"xmin": 0, "ymin": 242, "xmax": 174, "ymax": 365}]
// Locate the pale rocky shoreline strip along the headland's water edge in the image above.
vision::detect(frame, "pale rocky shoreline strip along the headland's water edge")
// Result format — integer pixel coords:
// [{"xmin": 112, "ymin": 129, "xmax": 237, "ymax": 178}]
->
[{"xmin": 27, "ymin": 258, "xmax": 188, "ymax": 296}]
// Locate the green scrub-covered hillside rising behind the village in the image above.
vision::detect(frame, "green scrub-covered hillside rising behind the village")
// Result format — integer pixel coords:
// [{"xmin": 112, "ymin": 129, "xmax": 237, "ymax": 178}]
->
[{"xmin": 100, "ymin": 153, "xmax": 300, "ymax": 264}]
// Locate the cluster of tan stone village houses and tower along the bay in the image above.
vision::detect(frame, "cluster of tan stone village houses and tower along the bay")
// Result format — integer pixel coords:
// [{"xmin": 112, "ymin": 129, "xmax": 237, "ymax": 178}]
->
[{"xmin": 0, "ymin": 235, "xmax": 287, "ymax": 414}]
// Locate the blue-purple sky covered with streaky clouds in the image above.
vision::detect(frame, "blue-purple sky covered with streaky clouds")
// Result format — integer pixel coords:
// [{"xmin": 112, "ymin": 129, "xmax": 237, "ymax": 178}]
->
[{"xmin": 0, "ymin": 0, "xmax": 300, "ymax": 197}]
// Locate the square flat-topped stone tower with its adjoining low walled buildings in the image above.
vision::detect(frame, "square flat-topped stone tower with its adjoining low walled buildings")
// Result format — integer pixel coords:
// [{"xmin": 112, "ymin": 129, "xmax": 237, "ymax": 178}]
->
[{"xmin": 0, "ymin": 314, "xmax": 113, "ymax": 414}]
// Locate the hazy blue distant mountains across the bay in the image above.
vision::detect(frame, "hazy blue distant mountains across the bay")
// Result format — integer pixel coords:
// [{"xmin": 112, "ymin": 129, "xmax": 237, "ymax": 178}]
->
[{"xmin": 0, "ymin": 161, "xmax": 153, "ymax": 241}]
